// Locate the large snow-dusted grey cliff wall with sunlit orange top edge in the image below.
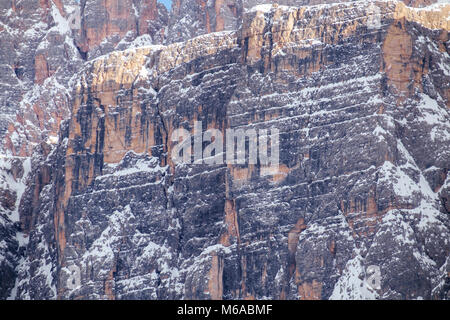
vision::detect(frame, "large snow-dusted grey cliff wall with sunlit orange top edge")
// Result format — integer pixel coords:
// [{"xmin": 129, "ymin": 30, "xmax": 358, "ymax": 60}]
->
[{"xmin": 8, "ymin": 1, "xmax": 449, "ymax": 299}]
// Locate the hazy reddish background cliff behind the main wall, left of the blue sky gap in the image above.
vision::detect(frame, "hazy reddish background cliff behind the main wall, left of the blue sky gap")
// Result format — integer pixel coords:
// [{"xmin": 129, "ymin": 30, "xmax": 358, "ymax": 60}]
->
[{"xmin": 0, "ymin": 0, "xmax": 168, "ymax": 157}]
